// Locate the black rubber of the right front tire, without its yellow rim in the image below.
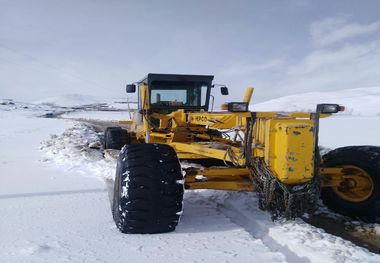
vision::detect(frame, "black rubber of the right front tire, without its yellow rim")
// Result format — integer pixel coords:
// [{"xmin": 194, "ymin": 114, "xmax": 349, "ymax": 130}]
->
[{"xmin": 321, "ymin": 146, "xmax": 380, "ymax": 221}]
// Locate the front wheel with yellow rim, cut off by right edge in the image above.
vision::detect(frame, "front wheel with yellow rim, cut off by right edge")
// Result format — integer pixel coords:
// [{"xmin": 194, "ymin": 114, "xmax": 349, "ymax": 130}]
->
[{"xmin": 321, "ymin": 146, "xmax": 380, "ymax": 221}]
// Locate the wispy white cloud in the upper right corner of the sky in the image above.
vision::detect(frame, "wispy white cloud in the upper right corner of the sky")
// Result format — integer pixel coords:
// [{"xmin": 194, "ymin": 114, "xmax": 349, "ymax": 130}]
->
[{"xmin": 310, "ymin": 17, "xmax": 380, "ymax": 46}]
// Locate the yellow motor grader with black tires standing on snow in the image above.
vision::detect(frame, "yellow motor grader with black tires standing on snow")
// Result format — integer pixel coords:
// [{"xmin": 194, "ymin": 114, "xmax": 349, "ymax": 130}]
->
[{"xmin": 104, "ymin": 74, "xmax": 380, "ymax": 233}]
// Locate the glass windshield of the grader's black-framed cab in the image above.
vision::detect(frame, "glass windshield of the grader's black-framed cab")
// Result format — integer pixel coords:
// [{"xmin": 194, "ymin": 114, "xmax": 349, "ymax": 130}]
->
[{"xmin": 150, "ymin": 81, "xmax": 208, "ymax": 108}]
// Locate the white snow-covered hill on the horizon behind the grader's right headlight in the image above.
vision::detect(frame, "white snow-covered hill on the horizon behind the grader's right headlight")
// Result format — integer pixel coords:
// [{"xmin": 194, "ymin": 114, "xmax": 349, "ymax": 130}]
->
[{"xmin": 250, "ymin": 87, "xmax": 380, "ymax": 116}]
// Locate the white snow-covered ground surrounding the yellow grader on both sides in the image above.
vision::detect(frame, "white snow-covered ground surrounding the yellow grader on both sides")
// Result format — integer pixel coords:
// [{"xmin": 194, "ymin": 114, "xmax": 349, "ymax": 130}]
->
[{"xmin": 0, "ymin": 88, "xmax": 380, "ymax": 262}]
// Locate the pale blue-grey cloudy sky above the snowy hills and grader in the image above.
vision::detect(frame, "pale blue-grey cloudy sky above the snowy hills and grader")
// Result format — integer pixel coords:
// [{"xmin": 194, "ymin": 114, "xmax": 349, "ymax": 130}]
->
[{"xmin": 0, "ymin": 0, "xmax": 380, "ymax": 102}]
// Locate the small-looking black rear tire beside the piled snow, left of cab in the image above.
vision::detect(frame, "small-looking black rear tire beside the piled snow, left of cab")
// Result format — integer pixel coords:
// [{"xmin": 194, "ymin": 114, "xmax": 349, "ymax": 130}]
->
[{"xmin": 103, "ymin": 127, "xmax": 131, "ymax": 150}]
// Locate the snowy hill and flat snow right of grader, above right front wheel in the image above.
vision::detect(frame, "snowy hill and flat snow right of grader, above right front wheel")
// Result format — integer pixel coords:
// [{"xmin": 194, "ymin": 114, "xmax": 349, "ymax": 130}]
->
[{"xmin": 250, "ymin": 87, "xmax": 380, "ymax": 149}]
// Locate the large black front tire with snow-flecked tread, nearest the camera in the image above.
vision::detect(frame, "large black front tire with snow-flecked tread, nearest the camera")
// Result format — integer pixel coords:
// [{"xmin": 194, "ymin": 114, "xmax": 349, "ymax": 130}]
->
[{"xmin": 112, "ymin": 144, "xmax": 184, "ymax": 234}]
